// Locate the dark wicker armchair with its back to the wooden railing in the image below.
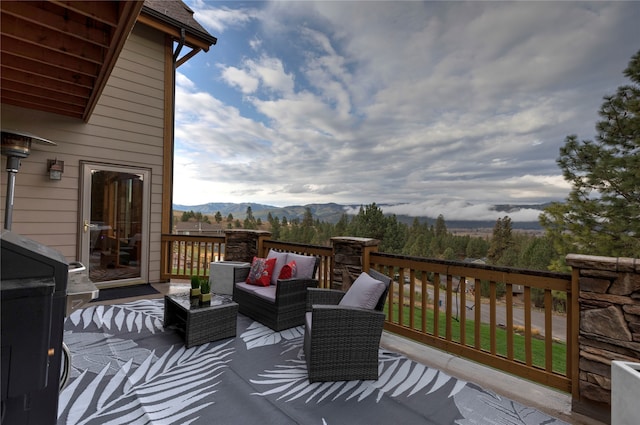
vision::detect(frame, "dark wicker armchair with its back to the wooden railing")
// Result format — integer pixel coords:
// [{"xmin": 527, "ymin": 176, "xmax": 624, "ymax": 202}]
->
[{"xmin": 304, "ymin": 270, "xmax": 391, "ymax": 382}]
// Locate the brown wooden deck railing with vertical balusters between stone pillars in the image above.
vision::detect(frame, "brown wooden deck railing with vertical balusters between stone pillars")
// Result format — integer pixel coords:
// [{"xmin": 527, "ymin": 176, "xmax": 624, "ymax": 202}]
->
[{"xmin": 162, "ymin": 235, "xmax": 578, "ymax": 392}]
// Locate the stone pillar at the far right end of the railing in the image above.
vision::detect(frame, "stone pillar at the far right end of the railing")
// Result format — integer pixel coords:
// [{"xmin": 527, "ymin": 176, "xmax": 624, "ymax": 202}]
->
[{"xmin": 566, "ymin": 254, "xmax": 640, "ymax": 423}]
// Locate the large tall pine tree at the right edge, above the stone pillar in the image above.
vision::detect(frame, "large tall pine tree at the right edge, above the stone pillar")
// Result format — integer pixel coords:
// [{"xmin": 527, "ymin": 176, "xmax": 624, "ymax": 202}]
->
[{"xmin": 540, "ymin": 51, "xmax": 640, "ymax": 262}]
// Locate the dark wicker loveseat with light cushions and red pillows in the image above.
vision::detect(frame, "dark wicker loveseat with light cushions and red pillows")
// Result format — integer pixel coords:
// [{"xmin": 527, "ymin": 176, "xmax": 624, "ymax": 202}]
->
[{"xmin": 233, "ymin": 250, "xmax": 320, "ymax": 331}]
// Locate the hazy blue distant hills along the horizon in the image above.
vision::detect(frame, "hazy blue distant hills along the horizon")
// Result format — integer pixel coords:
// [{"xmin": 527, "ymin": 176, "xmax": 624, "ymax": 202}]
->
[{"xmin": 173, "ymin": 202, "xmax": 548, "ymax": 230}]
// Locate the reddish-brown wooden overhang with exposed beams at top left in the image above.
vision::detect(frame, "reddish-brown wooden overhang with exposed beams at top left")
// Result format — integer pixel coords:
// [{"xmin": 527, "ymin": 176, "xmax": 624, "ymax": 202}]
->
[{"xmin": 0, "ymin": 1, "xmax": 143, "ymax": 121}]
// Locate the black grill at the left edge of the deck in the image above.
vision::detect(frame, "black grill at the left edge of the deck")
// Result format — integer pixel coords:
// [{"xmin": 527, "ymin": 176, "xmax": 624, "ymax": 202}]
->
[{"xmin": 0, "ymin": 230, "xmax": 69, "ymax": 425}]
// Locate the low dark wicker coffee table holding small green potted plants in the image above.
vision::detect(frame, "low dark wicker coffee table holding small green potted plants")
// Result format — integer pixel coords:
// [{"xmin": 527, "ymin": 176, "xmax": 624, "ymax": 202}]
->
[{"xmin": 164, "ymin": 293, "xmax": 238, "ymax": 348}]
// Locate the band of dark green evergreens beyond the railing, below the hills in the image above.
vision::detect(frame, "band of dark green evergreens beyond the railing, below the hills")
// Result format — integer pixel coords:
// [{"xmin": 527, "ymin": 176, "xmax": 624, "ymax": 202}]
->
[{"xmin": 190, "ymin": 203, "xmax": 554, "ymax": 270}]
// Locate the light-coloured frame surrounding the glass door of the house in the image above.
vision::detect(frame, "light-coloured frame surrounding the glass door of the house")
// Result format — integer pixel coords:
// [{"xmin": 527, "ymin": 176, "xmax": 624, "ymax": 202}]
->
[{"xmin": 78, "ymin": 161, "xmax": 151, "ymax": 288}]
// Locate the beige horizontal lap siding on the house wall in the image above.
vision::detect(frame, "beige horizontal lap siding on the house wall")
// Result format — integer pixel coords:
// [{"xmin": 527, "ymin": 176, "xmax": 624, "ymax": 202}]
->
[{"xmin": 0, "ymin": 24, "xmax": 170, "ymax": 282}]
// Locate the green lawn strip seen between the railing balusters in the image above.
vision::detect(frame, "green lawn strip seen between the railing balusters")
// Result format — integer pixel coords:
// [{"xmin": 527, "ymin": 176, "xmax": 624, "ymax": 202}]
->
[{"xmin": 385, "ymin": 304, "xmax": 567, "ymax": 375}]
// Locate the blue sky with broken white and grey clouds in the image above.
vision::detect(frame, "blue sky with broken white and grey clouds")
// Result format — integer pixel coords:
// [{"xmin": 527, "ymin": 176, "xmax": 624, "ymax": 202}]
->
[{"xmin": 174, "ymin": 0, "xmax": 640, "ymax": 221}]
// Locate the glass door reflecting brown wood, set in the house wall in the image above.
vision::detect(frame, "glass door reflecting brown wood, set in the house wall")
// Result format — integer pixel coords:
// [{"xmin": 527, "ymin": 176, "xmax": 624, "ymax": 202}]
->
[{"xmin": 81, "ymin": 162, "xmax": 150, "ymax": 287}]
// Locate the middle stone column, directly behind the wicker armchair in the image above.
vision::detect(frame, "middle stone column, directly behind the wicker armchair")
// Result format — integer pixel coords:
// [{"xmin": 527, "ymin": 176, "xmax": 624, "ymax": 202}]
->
[{"xmin": 331, "ymin": 236, "xmax": 380, "ymax": 291}]
